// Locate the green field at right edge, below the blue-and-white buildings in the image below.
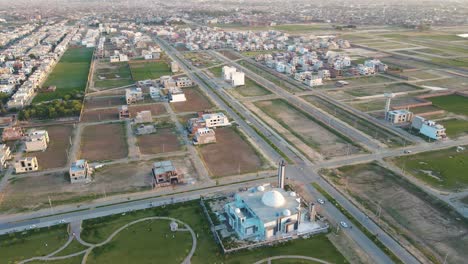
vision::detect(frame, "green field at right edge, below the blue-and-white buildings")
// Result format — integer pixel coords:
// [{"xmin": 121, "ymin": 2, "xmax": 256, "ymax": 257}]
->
[{"xmin": 393, "ymin": 148, "xmax": 468, "ymax": 191}]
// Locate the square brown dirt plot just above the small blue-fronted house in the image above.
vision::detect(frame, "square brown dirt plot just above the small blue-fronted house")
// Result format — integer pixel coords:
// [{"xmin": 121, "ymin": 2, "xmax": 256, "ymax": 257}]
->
[{"xmin": 80, "ymin": 123, "xmax": 128, "ymax": 161}]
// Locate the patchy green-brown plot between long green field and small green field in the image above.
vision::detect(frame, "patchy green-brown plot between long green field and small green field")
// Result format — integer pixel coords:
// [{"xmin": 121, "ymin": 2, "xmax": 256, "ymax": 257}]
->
[{"xmin": 94, "ymin": 62, "xmax": 134, "ymax": 90}]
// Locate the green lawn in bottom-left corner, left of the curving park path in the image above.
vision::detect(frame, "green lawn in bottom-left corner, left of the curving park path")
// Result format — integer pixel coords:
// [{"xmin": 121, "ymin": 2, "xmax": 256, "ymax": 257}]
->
[{"xmin": 0, "ymin": 225, "xmax": 68, "ymax": 263}]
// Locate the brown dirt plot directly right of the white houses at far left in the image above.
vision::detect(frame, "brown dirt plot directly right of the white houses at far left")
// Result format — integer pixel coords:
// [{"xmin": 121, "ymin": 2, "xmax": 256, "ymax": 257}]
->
[{"xmin": 25, "ymin": 125, "xmax": 73, "ymax": 169}]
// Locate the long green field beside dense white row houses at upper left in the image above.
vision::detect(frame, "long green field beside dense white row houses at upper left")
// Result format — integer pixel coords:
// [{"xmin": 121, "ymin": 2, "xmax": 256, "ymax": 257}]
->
[{"xmin": 33, "ymin": 47, "xmax": 93, "ymax": 103}]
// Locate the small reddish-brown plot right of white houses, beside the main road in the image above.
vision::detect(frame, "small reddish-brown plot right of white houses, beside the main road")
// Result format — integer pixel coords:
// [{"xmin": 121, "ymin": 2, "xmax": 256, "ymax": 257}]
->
[{"xmin": 171, "ymin": 88, "xmax": 213, "ymax": 113}]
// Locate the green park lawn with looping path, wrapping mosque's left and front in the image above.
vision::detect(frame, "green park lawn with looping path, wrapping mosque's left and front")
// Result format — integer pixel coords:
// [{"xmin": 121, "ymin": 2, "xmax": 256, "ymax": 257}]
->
[{"xmin": 82, "ymin": 201, "xmax": 346, "ymax": 264}]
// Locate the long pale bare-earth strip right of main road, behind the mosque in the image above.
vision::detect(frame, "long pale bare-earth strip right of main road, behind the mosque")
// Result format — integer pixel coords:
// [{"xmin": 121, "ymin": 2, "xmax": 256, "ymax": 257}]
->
[{"xmin": 255, "ymin": 99, "xmax": 362, "ymax": 158}]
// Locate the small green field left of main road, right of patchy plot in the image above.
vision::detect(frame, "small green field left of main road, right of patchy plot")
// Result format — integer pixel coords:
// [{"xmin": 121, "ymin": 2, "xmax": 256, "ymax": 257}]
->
[{"xmin": 130, "ymin": 61, "xmax": 171, "ymax": 81}]
